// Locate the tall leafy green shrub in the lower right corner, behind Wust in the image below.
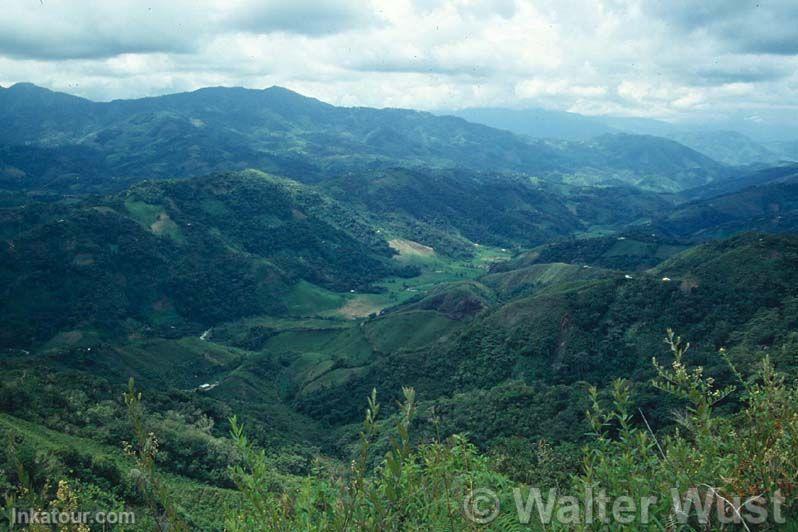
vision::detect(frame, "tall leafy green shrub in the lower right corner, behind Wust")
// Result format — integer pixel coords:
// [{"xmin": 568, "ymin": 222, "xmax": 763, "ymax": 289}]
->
[{"xmin": 579, "ymin": 332, "xmax": 798, "ymax": 529}]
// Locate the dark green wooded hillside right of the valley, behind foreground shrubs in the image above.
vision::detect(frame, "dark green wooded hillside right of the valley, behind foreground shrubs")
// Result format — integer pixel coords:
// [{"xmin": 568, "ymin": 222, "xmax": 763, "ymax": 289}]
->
[{"xmin": 292, "ymin": 234, "xmax": 798, "ymax": 432}]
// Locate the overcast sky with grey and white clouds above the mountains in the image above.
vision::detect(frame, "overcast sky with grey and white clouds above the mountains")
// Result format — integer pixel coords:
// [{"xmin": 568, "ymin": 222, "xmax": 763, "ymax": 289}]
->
[{"xmin": 0, "ymin": 0, "xmax": 798, "ymax": 122}]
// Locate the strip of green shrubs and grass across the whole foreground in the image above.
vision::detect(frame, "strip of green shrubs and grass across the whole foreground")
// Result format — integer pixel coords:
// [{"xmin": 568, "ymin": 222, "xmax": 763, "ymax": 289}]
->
[{"xmin": 0, "ymin": 331, "xmax": 798, "ymax": 532}]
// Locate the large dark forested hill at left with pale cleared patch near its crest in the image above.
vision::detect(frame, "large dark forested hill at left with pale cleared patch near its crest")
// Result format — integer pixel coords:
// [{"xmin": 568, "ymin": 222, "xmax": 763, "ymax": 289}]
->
[{"xmin": 0, "ymin": 172, "xmax": 415, "ymax": 347}]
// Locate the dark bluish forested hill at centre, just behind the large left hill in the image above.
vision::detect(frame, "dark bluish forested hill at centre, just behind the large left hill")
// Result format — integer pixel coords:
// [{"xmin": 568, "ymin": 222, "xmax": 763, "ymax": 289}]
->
[{"xmin": 324, "ymin": 169, "xmax": 583, "ymax": 252}]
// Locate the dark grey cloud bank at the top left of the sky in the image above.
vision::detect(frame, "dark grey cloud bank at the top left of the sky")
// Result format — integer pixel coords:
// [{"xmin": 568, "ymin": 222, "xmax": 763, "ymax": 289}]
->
[{"xmin": 0, "ymin": 0, "xmax": 379, "ymax": 60}]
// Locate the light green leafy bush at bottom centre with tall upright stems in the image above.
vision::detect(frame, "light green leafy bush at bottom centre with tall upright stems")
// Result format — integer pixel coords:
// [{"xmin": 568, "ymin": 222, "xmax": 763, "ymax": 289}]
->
[{"xmin": 227, "ymin": 388, "xmax": 509, "ymax": 530}]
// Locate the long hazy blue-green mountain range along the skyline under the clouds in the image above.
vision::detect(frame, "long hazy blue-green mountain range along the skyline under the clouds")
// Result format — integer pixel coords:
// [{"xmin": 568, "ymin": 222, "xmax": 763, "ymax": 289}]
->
[{"xmin": 0, "ymin": 84, "xmax": 725, "ymax": 192}]
